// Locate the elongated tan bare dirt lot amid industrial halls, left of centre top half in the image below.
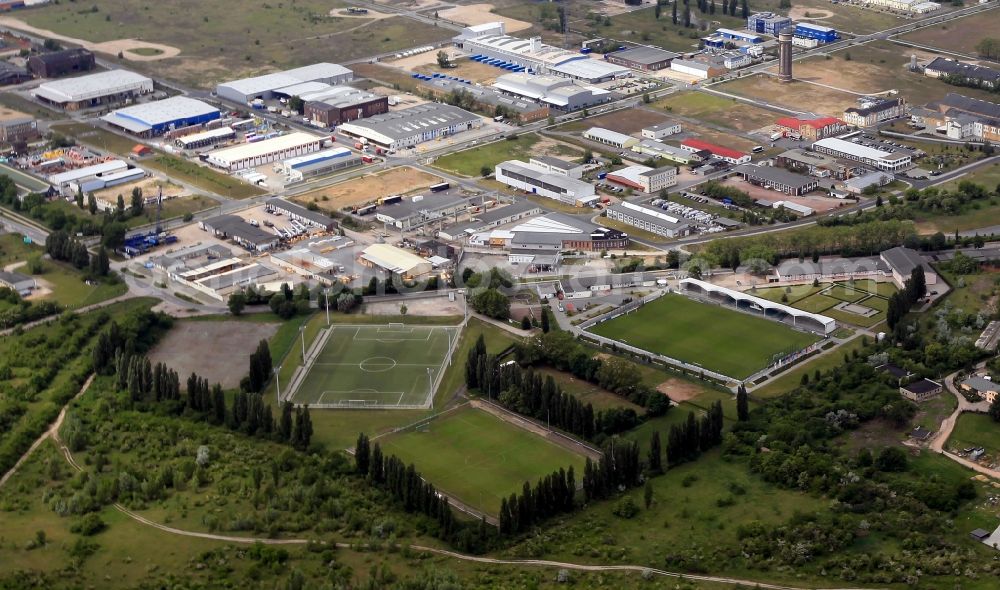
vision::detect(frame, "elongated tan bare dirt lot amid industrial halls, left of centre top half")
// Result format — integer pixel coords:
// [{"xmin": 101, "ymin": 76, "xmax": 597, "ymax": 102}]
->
[{"xmin": 292, "ymin": 166, "xmax": 441, "ymax": 210}]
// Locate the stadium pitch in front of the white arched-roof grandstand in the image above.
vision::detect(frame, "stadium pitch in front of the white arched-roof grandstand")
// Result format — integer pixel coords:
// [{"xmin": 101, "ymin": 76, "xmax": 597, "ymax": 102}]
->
[{"xmin": 590, "ymin": 294, "xmax": 819, "ymax": 379}]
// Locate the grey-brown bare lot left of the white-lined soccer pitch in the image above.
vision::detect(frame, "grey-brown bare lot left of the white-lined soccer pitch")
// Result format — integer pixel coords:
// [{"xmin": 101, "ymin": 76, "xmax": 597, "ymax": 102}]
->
[{"xmin": 149, "ymin": 321, "xmax": 278, "ymax": 389}]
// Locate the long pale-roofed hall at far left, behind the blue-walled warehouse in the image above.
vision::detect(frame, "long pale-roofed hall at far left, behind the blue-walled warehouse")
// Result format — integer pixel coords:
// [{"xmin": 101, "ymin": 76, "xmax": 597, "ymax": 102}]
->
[{"xmin": 32, "ymin": 70, "xmax": 153, "ymax": 111}]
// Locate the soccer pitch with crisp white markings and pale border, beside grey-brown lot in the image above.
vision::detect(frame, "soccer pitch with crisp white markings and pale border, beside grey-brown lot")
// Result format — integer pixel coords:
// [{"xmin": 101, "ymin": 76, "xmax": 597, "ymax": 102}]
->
[{"xmin": 291, "ymin": 325, "xmax": 458, "ymax": 408}]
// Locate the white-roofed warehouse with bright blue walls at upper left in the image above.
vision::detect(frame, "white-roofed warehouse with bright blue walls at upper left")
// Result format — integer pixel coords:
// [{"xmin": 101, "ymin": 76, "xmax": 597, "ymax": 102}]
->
[{"xmin": 101, "ymin": 96, "xmax": 220, "ymax": 137}]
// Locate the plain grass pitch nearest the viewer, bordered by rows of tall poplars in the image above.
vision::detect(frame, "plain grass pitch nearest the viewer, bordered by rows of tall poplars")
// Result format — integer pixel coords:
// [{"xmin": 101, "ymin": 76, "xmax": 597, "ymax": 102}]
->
[{"xmin": 377, "ymin": 406, "xmax": 584, "ymax": 514}]
